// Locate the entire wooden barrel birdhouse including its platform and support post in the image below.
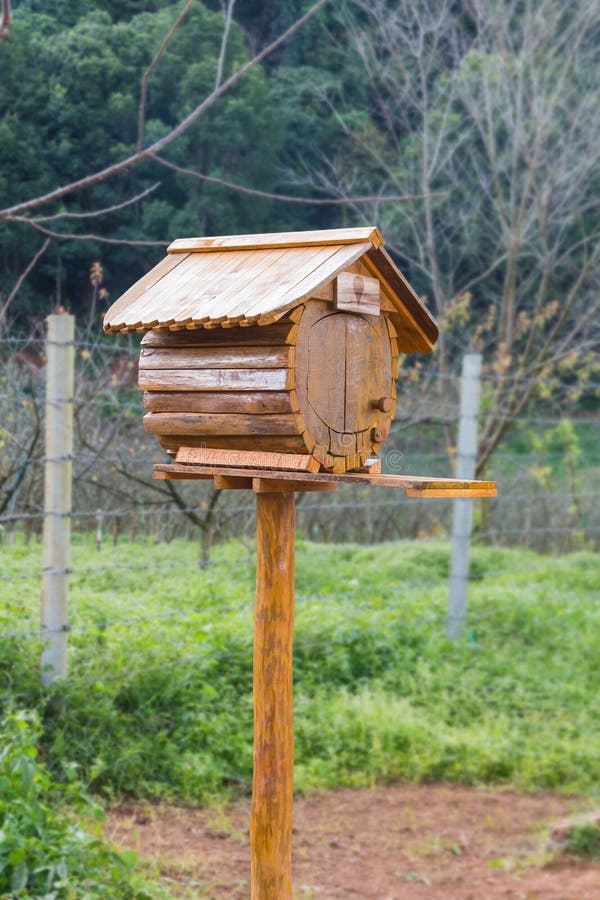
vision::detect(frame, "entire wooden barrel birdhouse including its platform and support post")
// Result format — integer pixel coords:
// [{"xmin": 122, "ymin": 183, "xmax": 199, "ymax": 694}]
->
[{"xmin": 104, "ymin": 228, "xmax": 496, "ymax": 900}]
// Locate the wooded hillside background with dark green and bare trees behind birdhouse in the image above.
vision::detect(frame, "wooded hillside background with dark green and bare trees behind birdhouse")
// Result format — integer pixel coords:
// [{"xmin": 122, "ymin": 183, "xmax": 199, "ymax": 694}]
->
[{"xmin": 0, "ymin": 0, "xmax": 600, "ymax": 549}]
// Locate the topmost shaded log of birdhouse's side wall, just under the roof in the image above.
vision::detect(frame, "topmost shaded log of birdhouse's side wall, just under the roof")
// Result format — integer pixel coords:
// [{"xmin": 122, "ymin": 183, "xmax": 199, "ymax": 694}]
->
[{"xmin": 141, "ymin": 323, "xmax": 298, "ymax": 347}]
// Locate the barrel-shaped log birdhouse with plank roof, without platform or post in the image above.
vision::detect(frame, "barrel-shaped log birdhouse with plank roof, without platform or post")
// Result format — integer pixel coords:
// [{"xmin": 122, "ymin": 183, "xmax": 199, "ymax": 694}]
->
[{"xmin": 104, "ymin": 228, "xmax": 438, "ymax": 473}]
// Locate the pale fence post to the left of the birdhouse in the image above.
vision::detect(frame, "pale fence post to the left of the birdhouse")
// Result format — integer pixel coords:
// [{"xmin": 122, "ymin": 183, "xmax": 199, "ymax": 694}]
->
[{"xmin": 41, "ymin": 314, "xmax": 75, "ymax": 685}]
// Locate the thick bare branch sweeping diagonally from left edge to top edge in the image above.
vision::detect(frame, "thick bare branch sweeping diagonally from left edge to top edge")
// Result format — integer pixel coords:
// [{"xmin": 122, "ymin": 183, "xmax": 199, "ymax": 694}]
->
[{"xmin": 0, "ymin": 0, "xmax": 329, "ymax": 219}]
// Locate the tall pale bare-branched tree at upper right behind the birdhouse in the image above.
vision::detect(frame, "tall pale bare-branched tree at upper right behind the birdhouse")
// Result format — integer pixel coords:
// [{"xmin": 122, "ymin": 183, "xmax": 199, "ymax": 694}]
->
[{"xmin": 307, "ymin": 0, "xmax": 600, "ymax": 473}]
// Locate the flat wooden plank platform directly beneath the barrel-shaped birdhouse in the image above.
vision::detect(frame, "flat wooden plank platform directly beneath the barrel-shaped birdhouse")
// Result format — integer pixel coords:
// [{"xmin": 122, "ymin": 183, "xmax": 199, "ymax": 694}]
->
[{"xmin": 152, "ymin": 463, "xmax": 497, "ymax": 499}]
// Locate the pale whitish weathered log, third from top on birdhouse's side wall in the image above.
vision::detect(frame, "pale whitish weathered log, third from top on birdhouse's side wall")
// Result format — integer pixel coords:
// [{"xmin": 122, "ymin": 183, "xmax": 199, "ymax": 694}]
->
[{"xmin": 138, "ymin": 369, "xmax": 294, "ymax": 391}]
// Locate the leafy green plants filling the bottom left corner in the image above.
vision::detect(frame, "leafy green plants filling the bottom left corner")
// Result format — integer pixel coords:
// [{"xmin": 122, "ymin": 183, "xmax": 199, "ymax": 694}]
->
[{"xmin": 0, "ymin": 712, "xmax": 157, "ymax": 900}]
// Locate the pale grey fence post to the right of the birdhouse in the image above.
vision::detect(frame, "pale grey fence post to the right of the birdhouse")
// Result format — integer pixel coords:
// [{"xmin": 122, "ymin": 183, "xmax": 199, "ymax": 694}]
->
[{"xmin": 447, "ymin": 353, "xmax": 481, "ymax": 640}]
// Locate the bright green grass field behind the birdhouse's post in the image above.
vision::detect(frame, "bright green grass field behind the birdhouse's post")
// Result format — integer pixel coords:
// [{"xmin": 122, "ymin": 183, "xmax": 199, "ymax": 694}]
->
[{"xmin": 0, "ymin": 540, "xmax": 600, "ymax": 803}]
